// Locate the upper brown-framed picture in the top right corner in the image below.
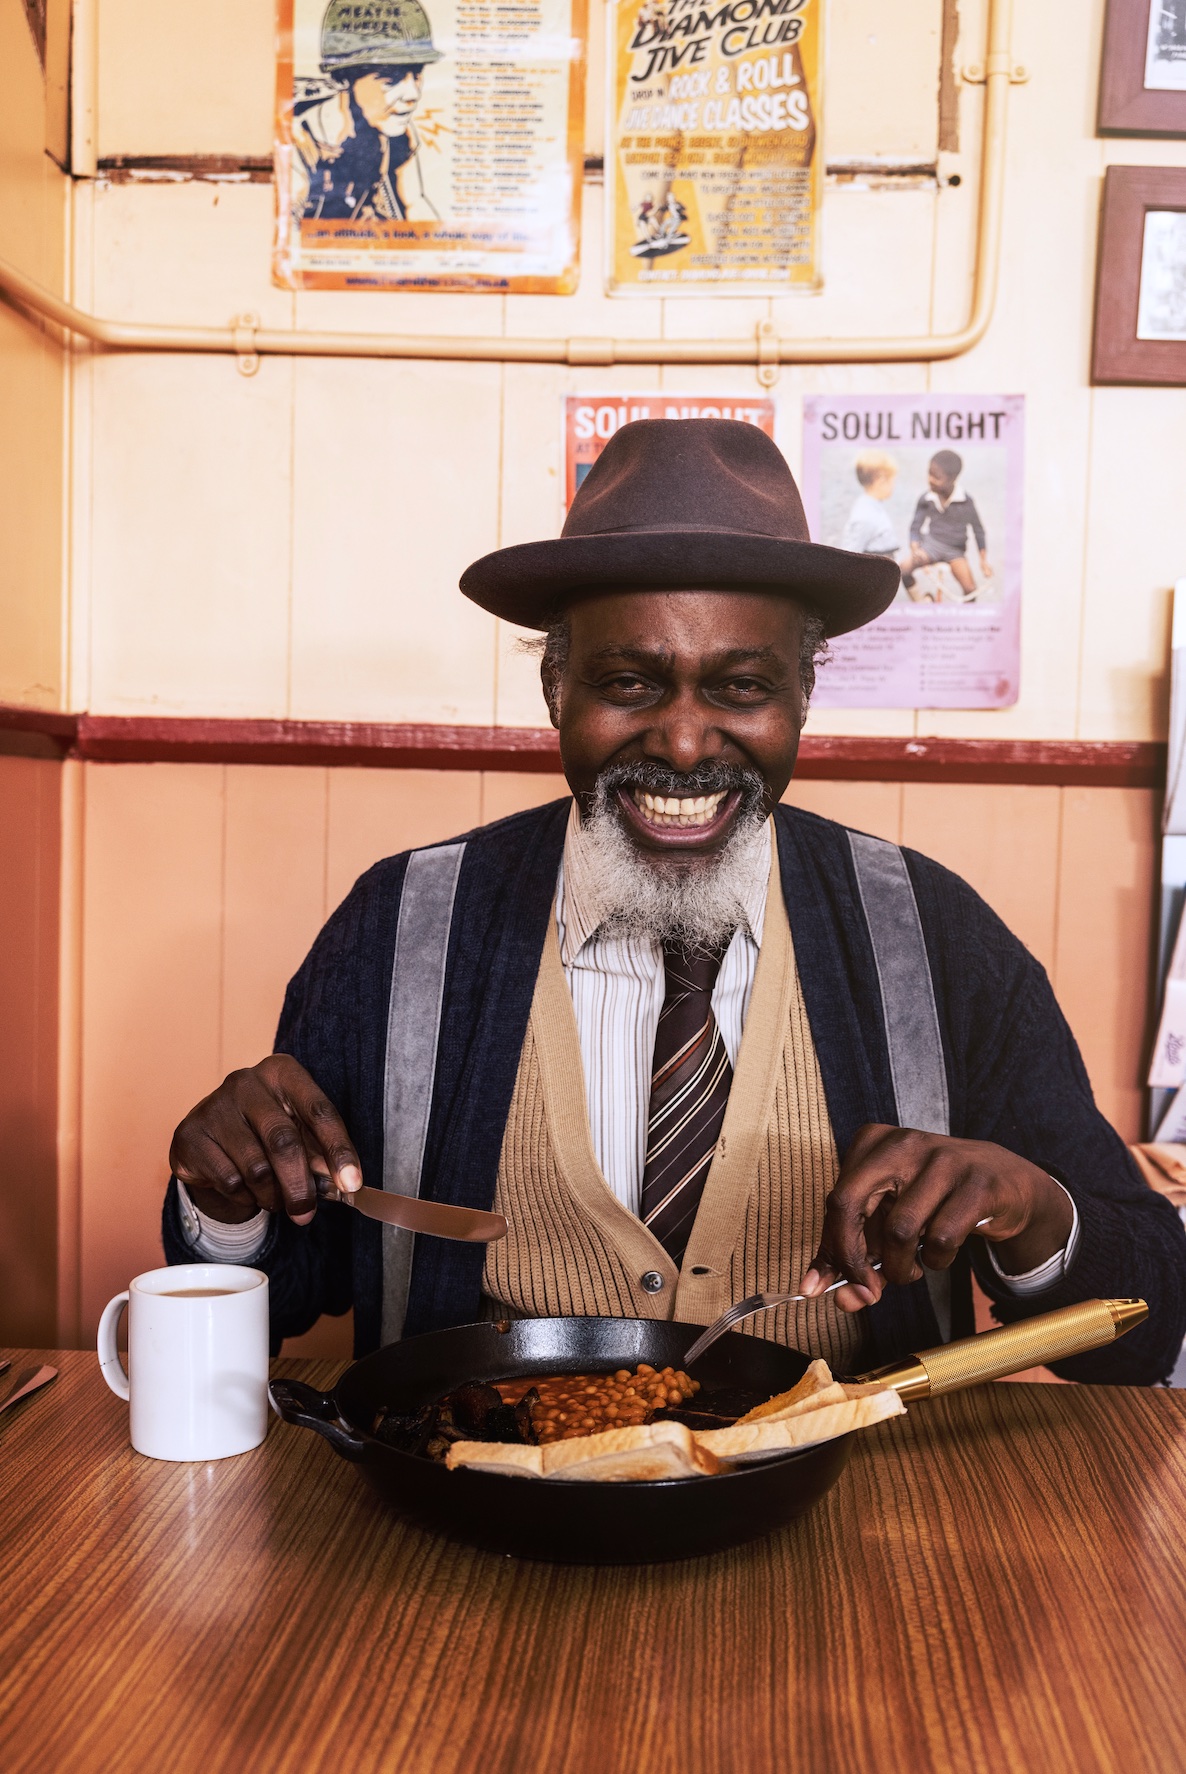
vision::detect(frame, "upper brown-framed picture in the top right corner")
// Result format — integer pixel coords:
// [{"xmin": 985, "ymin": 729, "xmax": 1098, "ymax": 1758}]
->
[{"xmin": 1099, "ymin": 0, "xmax": 1186, "ymax": 135}]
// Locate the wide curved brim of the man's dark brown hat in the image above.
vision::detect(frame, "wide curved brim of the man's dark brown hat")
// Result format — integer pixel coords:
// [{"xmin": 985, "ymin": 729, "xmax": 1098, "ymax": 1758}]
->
[{"xmin": 461, "ymin": 530, "xmax": 901, "ymax": 637}]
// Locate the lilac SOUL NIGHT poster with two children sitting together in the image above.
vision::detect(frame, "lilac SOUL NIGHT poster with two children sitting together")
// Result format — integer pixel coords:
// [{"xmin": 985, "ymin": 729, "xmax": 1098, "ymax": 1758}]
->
[{"xmin": 803, "ymin": 394, "xmax": 1025, "ymax": 708}]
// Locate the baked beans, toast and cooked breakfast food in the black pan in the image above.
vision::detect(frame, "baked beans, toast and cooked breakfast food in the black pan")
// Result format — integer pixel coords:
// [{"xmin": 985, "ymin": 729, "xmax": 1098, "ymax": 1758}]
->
[{"xmin": 374, "ymin": 1361, "xmax": 906, "ymax": 1481}]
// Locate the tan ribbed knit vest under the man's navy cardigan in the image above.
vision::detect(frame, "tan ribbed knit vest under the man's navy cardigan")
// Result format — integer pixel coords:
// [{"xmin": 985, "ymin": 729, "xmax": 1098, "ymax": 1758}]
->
[{"xmin": 484, "ymin": 837, "xmax": 865, "ymax": 1373}]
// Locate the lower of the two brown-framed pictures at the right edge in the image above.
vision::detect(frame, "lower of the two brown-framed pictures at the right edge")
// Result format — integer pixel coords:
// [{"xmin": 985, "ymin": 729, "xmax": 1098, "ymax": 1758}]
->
[{"xmin": 1092, "ymin": 167, "xmax": 1186, "ymax": 387}]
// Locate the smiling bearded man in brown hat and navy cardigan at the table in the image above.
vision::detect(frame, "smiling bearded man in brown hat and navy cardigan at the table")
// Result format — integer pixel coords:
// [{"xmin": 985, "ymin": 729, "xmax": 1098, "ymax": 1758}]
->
[{"xmin": 165, "ymin": 419, "xmax": 1186, "ymax": 1382}]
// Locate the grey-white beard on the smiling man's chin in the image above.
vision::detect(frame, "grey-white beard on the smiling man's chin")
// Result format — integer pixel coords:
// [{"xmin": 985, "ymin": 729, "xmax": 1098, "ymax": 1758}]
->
[{"xmin": 581, "ymin": 784, "xmax": 769, "ymax": 951}]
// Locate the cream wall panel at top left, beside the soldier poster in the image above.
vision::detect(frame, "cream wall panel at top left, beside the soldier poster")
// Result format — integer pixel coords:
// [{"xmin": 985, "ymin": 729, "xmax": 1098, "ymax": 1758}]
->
[{"xmin": 96, "ymin": 0, "xmax": 275, "ymax": 158}]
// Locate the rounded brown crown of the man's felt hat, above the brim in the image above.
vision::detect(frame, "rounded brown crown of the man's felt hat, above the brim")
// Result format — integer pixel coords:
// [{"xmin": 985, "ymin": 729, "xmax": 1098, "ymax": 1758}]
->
[{"xmin": 562, "ymin": 419, "xmax": 810, "ymax": 543}]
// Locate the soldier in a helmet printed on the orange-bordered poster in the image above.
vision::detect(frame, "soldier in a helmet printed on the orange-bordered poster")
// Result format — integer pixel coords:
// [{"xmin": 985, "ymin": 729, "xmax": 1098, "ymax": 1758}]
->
[{"xmin": 293, "ymin": 0, "xmax": 441, "ymax": 222}]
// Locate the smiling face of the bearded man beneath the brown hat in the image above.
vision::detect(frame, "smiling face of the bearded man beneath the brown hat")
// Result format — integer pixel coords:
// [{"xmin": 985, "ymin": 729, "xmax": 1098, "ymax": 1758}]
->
[{"xmin": 550, "ymin": 591, "xmax": 803, "ymax": 864}]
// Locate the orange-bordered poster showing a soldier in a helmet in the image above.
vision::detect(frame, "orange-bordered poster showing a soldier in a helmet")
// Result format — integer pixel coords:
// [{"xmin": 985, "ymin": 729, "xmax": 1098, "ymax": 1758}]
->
[{"xmin": 273, "ymin": 0, "xmax": 585, "ymax": 294}]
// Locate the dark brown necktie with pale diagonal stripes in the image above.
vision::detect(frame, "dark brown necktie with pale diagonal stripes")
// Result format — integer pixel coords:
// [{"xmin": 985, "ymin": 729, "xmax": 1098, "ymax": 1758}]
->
[{"xmin": 642, "ymin": 942, "xmax": 732, "ymax": 1263}]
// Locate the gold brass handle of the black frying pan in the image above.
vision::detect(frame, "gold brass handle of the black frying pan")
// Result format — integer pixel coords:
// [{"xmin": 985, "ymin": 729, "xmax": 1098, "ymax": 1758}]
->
[{"xmin": 850, "ymin": 1300, "xmax": 1149, "ymax": 1398}]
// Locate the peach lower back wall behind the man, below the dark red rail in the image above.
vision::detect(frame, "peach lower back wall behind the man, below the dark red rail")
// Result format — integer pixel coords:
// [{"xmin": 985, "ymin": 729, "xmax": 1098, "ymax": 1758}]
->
[{"xmin": 60, "ymin": 765, "xmax": 1154, "ymax": 1338}]
